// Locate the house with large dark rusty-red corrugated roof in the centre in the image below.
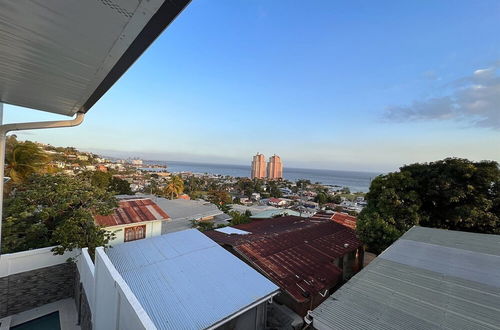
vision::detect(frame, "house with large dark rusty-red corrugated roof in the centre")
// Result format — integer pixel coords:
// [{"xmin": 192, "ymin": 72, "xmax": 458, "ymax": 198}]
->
[{"xmin": 205, "ymin": 216, "xmax": 363, "ymax": 316}]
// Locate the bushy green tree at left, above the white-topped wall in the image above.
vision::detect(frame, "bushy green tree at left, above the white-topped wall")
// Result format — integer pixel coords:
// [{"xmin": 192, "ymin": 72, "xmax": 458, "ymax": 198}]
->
[{"xmin": 2, "ymin": 175, "xmax": 117, "ymax": 254}]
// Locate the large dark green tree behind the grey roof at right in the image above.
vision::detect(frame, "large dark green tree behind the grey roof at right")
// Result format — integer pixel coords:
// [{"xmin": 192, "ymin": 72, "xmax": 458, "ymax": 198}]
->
[{"xmin": 357, "ymin": 158, "xmax": 500, "ymax": 253}]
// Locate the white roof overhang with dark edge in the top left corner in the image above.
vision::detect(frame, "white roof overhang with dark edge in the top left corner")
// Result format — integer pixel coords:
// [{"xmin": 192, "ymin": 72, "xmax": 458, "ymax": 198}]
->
[{"xmin": 0, "ymin": 0, "xmax": 190, "ymax": 116}]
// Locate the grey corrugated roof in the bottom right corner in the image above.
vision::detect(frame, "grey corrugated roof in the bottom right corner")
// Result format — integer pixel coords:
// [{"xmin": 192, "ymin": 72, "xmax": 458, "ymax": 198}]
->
[{"xmin": 312, "ymin": 227, "xmax": 500, "ymax": 330}]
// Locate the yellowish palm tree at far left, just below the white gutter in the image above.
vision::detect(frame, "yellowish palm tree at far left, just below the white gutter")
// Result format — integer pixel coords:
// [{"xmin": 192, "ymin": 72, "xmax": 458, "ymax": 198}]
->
[{"xmin": 5, "ymin": 141, "xmax": 49, "ymax": 183}]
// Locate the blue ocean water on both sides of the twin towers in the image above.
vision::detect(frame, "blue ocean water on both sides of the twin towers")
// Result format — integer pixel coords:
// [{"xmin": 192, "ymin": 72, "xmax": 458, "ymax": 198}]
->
[{"xmin": 145, "ymin": 161, "xmax": 381, "ymax": 192}]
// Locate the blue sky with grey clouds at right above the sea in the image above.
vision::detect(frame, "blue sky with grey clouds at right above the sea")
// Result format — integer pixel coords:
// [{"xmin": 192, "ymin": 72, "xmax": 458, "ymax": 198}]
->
[{"xmin": 5, "ymin": 0, "xmax": 500, "ymax": 171}]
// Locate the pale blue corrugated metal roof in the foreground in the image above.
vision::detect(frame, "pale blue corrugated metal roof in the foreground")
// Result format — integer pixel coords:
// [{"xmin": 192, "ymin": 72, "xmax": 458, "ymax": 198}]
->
[{"xmin": 106, "ymin": 229, "xmax": 278, "ymax": 330}]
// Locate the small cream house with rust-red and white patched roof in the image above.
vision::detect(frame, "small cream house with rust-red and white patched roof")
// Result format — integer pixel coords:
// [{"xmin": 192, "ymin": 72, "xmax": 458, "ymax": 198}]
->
[{"xmin": 94, "ymin": 198, "xmax": 170, "ymax": 246}]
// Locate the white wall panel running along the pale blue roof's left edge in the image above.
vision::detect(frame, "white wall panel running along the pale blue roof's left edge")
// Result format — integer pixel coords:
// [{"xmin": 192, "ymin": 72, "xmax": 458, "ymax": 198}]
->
[{"xmin": 92, "ymin": 247, "xmax": 156, "ymax": 330}]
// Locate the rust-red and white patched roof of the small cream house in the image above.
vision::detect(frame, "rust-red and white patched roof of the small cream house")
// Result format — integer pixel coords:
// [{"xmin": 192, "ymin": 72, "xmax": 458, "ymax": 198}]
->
[{"xmin": 94, "ymin": 198, "xmax": 170, "ymax": 227}]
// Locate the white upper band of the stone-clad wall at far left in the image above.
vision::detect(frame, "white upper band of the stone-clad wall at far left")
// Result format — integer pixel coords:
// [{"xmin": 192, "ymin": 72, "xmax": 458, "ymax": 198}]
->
[{"xmin": 0, "ymin": 247, "xmax": 79, "ymax": 277}]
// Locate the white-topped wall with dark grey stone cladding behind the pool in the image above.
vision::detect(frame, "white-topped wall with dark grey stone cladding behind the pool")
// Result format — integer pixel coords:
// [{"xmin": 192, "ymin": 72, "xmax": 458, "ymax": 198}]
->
[{"xmin": 0, "ymin": 247, "xmax": 76, "ymax": 318}]
